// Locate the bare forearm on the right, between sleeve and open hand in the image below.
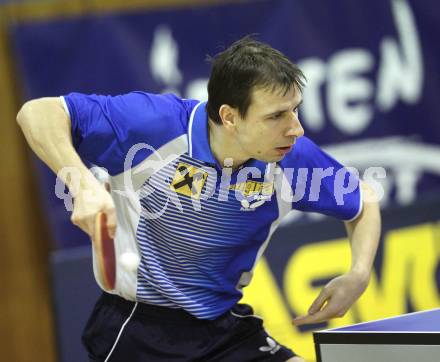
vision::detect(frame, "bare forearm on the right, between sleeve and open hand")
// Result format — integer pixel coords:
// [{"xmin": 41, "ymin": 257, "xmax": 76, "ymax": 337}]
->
[{"xmin": 345, "ymin": 183, "xmax": 381, "ymax": 282}]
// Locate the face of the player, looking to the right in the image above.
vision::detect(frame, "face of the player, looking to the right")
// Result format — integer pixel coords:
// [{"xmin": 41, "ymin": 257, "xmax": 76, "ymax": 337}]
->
[{"xmin": 235, "ymin": 87, "xmax": 304, "ymax": 162}]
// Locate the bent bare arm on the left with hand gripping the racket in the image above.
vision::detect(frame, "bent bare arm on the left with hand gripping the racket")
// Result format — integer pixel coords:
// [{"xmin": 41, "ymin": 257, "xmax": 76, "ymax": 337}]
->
[{"xmin": 17, "ymin": 98, "xmax": 116, "ymax": 235}]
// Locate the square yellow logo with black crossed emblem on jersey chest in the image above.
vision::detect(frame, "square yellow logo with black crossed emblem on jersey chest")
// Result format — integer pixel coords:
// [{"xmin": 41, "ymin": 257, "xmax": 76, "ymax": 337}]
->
[{"xmin": 170, "ymin": 162, "xmax": 208, "ymax": 199}]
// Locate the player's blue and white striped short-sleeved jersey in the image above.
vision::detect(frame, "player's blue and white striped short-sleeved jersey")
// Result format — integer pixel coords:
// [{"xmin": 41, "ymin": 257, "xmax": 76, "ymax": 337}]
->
[{"xmin": 62, "ymin": 92, "xmax": 362, "ymax": 319}]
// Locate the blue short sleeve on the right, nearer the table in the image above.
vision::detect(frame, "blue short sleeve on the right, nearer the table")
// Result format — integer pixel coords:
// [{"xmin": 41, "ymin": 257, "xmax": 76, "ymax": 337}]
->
[{"xmin": 280, "ymin": 137, "xmax": 362, "ymax": 221}]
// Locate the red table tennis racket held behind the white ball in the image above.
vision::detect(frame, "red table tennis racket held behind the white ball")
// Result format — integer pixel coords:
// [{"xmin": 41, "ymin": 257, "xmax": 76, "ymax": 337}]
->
[{"xmin": 92, "ymin": 212, "xmax": 116, "ymax": 291}]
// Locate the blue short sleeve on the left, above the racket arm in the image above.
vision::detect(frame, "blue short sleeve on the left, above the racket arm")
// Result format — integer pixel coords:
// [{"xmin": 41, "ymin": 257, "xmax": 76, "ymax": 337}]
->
[{"xmin": 62, "ymin": 92, "xmax": 197, "ymax": 175}]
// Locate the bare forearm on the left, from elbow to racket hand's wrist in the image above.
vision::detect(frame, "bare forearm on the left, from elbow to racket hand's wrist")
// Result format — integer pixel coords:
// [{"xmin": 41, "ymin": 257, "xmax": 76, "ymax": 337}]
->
[{"xmin": 17, "ymin": 98, "xmax": 97, "ymax": 189}]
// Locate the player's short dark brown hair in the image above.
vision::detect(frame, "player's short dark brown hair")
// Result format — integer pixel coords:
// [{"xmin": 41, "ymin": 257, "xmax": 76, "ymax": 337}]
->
[{"xmin": 206, "ymin": 36, "xmax": 305, "ymax": 124}]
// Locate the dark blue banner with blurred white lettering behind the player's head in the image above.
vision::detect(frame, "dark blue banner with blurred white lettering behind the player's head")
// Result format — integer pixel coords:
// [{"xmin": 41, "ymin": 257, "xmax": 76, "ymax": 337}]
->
[{"xmin": 11, "ymin": 0, "xmax": 440, "ymax": 247}]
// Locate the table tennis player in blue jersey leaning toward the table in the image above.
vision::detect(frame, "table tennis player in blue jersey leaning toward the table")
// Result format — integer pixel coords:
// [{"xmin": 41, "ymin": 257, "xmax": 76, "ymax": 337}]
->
[{"xmin": 17, "ymin": 37, "xmax": 380, "ymax": 362}]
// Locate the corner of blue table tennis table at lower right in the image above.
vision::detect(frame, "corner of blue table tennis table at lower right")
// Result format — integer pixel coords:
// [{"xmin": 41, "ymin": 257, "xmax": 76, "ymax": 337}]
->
[{"xmin": 313, "ymin": 309, "xmax": 440, "ymax": 362}]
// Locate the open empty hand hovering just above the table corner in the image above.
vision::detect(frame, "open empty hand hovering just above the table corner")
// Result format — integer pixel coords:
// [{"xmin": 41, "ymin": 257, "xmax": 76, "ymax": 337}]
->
[{"xmin": 292, "ymin": 271, "xmax": 369, "ymax": 326}]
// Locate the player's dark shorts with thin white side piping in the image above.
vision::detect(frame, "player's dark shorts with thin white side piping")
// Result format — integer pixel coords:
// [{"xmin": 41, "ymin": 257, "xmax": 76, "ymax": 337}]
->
[{"xmin": 82, "ymin": 293, "xmax": 295, "ymax": 362}]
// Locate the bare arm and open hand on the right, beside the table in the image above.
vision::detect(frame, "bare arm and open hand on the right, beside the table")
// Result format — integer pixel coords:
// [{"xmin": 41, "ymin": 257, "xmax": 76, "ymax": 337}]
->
[{"xmin": 293, "ymin": 182, "xmax": 381, "ymax": 326}]
